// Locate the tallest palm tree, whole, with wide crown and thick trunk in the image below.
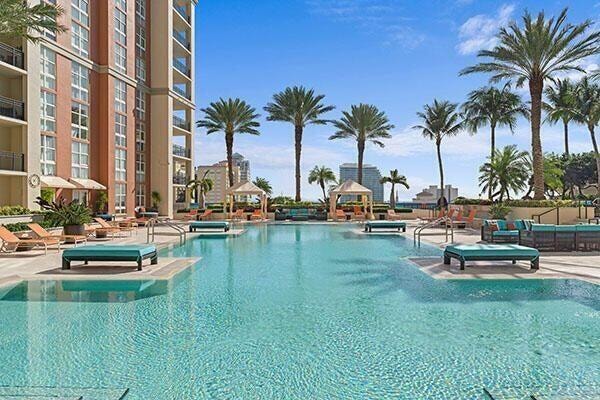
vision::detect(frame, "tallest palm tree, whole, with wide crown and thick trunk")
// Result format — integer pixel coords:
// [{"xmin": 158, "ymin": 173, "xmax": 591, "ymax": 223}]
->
[{"xmin": 460, "ymin": 9, "xmax": 600, "ymax": 199}]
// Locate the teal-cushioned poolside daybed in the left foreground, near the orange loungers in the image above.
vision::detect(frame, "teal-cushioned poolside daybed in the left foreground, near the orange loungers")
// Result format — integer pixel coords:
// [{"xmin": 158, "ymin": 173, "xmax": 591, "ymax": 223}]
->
[{"xmin": 62, "ymin": 245, "xmax": 158, "ymax": 271}]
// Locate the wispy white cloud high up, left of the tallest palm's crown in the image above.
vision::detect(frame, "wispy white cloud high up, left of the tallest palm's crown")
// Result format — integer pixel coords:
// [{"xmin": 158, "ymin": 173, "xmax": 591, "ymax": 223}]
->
[{"xmin": 457, "ymin": 4, "xmax": 515, "ymax": 55}]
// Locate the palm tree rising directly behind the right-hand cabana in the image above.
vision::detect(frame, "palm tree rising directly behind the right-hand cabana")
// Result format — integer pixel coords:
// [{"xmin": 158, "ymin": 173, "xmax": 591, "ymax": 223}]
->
[{"xmin": 329, "ymin": 104, "xmax": 394, "ymax": 184}]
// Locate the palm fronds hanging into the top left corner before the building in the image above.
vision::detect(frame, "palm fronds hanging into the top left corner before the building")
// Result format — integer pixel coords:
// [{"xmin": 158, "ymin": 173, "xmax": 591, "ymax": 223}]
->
[{"xmin": 0, "ymin": 0, "xmax": 67, "ymax": 43}]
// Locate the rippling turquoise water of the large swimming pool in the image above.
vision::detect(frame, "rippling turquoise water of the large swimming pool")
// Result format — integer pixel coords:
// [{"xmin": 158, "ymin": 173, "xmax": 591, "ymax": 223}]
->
[{"xmin": 0, "ymin": 225, "xmax": 600, "ymax": 400}]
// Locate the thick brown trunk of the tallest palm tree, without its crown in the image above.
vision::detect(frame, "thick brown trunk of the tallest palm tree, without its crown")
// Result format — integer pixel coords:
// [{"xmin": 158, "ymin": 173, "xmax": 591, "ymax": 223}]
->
[{"xmin": 529, "ymin": 78, "xmax": 545, "ymax": 200}]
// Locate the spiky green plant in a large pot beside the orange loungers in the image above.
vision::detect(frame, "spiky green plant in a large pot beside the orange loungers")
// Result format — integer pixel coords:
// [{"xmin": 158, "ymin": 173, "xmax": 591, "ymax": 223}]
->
[{"xmin": 36, "ymin": 197, "xmax": 92, "ymax": 235}]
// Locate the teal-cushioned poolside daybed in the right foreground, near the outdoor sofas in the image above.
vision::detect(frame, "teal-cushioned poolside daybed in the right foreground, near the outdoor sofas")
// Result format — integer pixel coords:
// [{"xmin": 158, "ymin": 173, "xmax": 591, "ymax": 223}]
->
[{"xmin": 444, "ymin": 244, "xmax": 540, "ymax": 270}]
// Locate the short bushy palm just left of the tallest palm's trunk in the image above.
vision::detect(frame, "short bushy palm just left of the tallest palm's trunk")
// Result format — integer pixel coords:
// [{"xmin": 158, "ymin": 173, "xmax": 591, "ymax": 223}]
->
[{"xmin": 479, "ymin": 145, "xmax": 530, "ymax": 202}]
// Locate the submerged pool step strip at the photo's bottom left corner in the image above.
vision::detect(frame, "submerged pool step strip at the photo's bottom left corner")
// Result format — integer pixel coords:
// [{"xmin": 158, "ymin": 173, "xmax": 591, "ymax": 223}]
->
[{"xmin": 0, "ymin": 386, "xmax": 129, "ymax": 400}]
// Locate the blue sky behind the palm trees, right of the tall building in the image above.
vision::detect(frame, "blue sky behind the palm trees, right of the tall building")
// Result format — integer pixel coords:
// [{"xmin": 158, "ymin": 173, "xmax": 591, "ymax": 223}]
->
[{"xmin": 196, "ymin": 0, "xmax": 600, "ymax": 199}]
